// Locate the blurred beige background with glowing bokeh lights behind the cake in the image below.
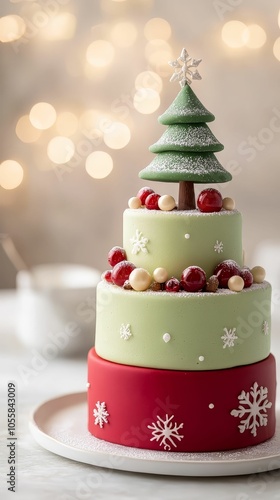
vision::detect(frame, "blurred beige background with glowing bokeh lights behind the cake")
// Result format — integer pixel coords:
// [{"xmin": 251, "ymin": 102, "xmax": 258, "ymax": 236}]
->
[{"xmin": 0, "ymin": 0, "xmax": 280, "ymax": 288}]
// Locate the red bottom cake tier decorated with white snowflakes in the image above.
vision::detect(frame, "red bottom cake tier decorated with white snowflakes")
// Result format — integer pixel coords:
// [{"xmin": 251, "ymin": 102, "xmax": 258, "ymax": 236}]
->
[{"xmin": 88, "ymin": 349, "xmax": 276, "ymax": 452}]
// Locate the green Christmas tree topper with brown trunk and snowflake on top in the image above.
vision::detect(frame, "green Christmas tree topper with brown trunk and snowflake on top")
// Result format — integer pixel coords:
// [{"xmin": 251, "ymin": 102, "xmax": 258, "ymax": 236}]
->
[{"xmin": 139, "ymin": 49, "xmax": 231, "ymax": 210}]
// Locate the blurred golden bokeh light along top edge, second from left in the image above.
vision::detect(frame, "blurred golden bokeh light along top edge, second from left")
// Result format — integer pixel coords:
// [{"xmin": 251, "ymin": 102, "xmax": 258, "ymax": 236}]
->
[{"xmin": 40, "ymin": 12, "xmax": 77, "ymax": 40}]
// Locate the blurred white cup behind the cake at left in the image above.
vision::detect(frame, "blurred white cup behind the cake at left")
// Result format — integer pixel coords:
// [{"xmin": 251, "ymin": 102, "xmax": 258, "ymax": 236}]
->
[{"xmin": 16, "ymin": 264, "xmax": 100, "ymax": 359}]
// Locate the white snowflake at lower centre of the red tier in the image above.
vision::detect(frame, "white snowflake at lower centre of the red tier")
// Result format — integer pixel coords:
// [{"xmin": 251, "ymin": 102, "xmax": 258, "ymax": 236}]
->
[{"xmin": 147, "ymin": 415, "xmax": 184, "ymax": 451}]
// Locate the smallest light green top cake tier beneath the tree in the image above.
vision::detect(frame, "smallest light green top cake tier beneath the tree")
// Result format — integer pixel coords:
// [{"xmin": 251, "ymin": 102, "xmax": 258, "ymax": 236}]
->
[{"xmin": 123, "ymin": 208, "xmax": 242, "ymax": 279}]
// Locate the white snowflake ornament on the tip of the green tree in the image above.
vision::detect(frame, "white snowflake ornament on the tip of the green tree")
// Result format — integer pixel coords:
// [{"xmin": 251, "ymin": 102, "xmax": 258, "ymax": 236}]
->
[{"xmin": 168, "ymin": 49, "xmax": 202, "ymax": 87}]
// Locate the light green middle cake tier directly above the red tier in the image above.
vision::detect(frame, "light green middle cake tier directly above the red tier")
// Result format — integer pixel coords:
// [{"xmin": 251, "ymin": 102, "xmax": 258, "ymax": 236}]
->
[{"xmin": 95, "ymin": 281, "xmax": 271, "ymax": 372}]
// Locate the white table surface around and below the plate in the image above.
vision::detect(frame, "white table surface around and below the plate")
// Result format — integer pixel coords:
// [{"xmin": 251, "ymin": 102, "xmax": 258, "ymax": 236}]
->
[{"xmin": 0, "ymin": 291, "xmax": 280, "ymax": 500}]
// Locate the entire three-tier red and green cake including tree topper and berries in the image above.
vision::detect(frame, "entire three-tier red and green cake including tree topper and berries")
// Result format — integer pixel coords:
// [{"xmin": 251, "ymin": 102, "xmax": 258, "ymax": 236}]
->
[{"xmin": 88, "ymin": 49, "xmax": 276, "ymax": 452}]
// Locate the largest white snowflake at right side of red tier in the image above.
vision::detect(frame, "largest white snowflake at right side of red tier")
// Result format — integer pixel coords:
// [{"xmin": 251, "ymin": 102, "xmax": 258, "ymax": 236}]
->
[{"xmin": 230, "ymin": 382, "xmax": 272, "ymax": 436}]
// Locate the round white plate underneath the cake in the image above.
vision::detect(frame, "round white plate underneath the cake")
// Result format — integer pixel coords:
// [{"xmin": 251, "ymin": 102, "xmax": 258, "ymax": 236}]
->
[{"xmin": 30, "ymin": 392, "xmax": 280, "ymax": 476}]
